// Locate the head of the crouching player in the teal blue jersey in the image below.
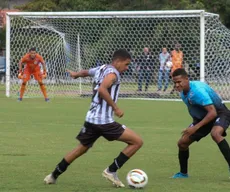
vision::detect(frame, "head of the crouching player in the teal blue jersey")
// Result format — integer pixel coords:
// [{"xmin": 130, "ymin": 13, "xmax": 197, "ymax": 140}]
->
[{"xmin": 172, "ymin": 68, "xmax": 189, "ymax": 92}]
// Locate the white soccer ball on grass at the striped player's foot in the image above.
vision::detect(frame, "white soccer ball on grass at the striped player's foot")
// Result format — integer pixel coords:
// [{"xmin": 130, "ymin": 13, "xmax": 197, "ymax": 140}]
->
[{"xmin": 126, "ymin": 169, "xmax": 148, "ymax": 189}]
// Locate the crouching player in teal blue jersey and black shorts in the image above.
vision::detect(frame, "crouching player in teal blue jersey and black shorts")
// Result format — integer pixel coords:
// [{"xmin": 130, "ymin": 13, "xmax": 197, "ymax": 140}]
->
[{"xmin": 172, "ymin": 68, "xmax": 230, "ymax": 178}]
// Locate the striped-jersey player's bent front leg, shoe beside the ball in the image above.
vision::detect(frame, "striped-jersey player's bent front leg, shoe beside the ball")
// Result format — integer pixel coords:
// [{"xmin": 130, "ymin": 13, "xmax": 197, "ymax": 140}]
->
[{"xmin": 102, "ymin": 122, "xmax": 143, "ymax": 187}]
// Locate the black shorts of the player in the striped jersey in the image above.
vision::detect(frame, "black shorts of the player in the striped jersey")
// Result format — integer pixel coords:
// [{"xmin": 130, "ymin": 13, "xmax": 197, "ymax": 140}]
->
[{"xmin": 76, "ymin": 122, "xmax": 126, "ymax": 147}]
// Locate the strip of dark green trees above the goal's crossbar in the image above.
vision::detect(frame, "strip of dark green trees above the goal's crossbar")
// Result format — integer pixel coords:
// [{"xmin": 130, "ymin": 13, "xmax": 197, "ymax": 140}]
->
[{"xmin": 14, "ymin": 0, "xmax": 230, "ymax": 28}]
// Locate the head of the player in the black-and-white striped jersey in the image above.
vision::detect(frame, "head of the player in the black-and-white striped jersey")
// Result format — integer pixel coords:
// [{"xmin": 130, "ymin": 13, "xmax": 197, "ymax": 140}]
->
[{"xmin": 112, "ymin": 49, "xmax": 131, "ymax": 73}]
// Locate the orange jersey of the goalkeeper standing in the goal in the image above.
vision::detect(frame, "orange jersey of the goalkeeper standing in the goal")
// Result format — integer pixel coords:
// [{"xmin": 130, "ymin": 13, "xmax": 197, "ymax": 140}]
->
[{"xmin": 21, "ymin": 53, "xmax": 44, "ymax": 72}]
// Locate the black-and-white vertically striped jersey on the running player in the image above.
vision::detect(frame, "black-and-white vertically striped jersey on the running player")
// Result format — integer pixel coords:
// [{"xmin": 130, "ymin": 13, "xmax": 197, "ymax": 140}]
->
[{"xmin": 85, "ymin": 65, "xmax": 121, "ymax": 124}]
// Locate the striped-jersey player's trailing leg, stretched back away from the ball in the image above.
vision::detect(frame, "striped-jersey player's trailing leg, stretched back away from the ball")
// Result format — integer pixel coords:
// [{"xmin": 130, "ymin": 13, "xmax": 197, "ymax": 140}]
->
[{"xmin": 44, "ymin": 123, "xmax": 100, "ymax": 184}]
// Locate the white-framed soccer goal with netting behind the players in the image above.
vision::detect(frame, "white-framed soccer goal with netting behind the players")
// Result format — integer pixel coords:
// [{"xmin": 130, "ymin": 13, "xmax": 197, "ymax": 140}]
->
[{"xmin": 6, "ymin": 10, "xmax": 230, "ymax": 101}]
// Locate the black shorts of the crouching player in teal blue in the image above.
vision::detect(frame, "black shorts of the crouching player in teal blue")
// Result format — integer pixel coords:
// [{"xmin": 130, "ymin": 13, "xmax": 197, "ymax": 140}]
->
[{"xmin": 189, "ymin": 113, "xmax": 230, "ymax": 141}]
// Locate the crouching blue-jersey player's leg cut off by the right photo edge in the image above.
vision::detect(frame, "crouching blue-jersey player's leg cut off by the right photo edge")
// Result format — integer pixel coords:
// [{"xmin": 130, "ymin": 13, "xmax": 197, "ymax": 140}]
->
[{"xmin": 211, "ymin": 116, "xmax": 230, "ymax": 170}]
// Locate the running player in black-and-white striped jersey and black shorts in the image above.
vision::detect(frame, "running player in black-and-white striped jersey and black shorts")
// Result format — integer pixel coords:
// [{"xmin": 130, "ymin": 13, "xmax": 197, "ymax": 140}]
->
[{"xmin": 44, "ymin": 49, "xmax": 143, "ymax": 187}]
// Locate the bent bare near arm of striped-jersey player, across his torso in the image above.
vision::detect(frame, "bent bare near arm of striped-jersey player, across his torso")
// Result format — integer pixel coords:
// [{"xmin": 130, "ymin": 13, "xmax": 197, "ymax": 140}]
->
[{"xmin": 98, "ymin": 73, "xmax": 124, "ymax": 117}]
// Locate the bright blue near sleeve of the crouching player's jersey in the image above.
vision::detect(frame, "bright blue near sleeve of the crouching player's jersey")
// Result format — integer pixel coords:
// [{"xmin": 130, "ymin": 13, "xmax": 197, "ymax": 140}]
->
[{"xmin": 191, "ymin": 88, "xmax": 213, "ymax": 106}]
